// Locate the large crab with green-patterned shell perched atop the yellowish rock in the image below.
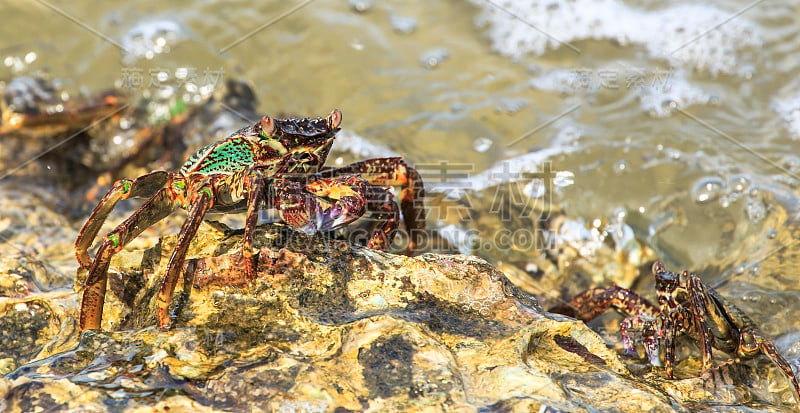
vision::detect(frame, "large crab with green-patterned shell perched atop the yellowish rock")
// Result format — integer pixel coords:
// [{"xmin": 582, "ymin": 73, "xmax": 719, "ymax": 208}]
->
[{"xmin": 75, "ymin": 109, "xmax": 425, "ymax": 330}]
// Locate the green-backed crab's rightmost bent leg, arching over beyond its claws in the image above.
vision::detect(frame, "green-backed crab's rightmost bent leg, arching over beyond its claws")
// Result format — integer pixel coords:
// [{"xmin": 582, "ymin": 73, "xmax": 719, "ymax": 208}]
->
[{"xmin": 324, "ymin": 158, "xmax": 425, "ymax": 253}]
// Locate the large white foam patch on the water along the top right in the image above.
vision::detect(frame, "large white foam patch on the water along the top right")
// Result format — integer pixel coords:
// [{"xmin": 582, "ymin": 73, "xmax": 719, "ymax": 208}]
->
[{"xmin": 473, "ymin": 0, "xmax": 762, "ymax": 76}]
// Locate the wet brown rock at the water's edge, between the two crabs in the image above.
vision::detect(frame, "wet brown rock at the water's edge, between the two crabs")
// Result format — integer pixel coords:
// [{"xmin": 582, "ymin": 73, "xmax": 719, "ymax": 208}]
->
[{"xmin": 430, "ymin": 188, "xmax": 658, "ymax": 308}]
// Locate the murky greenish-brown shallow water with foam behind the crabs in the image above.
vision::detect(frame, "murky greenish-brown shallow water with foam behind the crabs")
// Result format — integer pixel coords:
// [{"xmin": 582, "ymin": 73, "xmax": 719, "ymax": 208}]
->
[{"xmin": 0, "ymin": 0, "xmax": 800, "ymax": 406}]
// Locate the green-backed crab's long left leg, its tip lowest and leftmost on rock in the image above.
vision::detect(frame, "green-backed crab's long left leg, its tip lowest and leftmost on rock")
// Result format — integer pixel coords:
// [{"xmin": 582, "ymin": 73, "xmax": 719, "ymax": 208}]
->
[{"xmin": 79, "ymin": 188, "xmax": 178, "ymax": 330}]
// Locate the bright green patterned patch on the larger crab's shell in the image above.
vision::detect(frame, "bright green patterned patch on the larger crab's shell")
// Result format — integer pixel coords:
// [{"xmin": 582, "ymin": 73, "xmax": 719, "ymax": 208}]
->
[{"xmin": 181, "ymin": 139, "xmax": 255, "ymax": 174}]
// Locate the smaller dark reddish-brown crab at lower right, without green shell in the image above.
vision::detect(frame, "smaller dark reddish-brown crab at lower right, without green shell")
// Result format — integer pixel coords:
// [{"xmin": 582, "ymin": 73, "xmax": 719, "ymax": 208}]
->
[{"xmin": 549, "ymin": 262, "xmax": 800, "ymax": 402}]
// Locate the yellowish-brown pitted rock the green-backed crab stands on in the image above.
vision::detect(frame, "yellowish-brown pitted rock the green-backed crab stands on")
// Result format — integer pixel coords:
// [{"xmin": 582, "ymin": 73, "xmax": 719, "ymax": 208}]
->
[{"xmin": 0, "ymin": 225, "xmax": 692, "ymax": 412}]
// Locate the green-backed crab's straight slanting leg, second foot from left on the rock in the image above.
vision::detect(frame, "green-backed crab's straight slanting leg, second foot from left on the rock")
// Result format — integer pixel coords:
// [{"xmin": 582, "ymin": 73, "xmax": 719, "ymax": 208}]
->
[{"xmin": 157, "ymin": 185, "xmax": 214, "ymax": 329}]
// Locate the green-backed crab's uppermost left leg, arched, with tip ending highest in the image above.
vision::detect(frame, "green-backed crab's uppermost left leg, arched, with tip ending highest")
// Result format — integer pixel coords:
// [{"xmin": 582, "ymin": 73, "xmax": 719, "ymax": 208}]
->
[{"xmin": 75, "ymin": 171, "xmax": 170, "ymax": 268}]
